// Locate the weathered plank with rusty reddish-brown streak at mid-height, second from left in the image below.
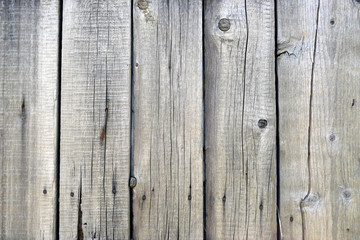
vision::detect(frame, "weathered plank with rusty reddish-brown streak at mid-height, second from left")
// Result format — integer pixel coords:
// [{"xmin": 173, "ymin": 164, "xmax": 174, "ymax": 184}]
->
[{"xmin": 60, "ymin": 0, "xmax": 131, "ymax": 239}]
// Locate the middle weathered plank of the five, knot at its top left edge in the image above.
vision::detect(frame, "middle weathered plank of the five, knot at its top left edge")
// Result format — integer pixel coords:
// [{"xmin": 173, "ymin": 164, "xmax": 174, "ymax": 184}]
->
[{"xmin": 133, "ymin": 0, "xmax": 203, "ymax": 239}]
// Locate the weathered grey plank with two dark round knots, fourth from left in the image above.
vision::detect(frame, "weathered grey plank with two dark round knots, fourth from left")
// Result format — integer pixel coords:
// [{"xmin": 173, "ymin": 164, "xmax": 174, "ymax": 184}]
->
[{"xmin": 205, "ymin": 0, "xmax": 276, "ymax": 239}]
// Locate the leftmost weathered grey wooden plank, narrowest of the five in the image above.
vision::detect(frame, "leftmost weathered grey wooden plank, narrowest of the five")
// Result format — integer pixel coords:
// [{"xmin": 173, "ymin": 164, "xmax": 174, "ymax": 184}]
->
[{"xmin": 0, "ymin": 1, "xmax": 59, "ymax": 239}]
